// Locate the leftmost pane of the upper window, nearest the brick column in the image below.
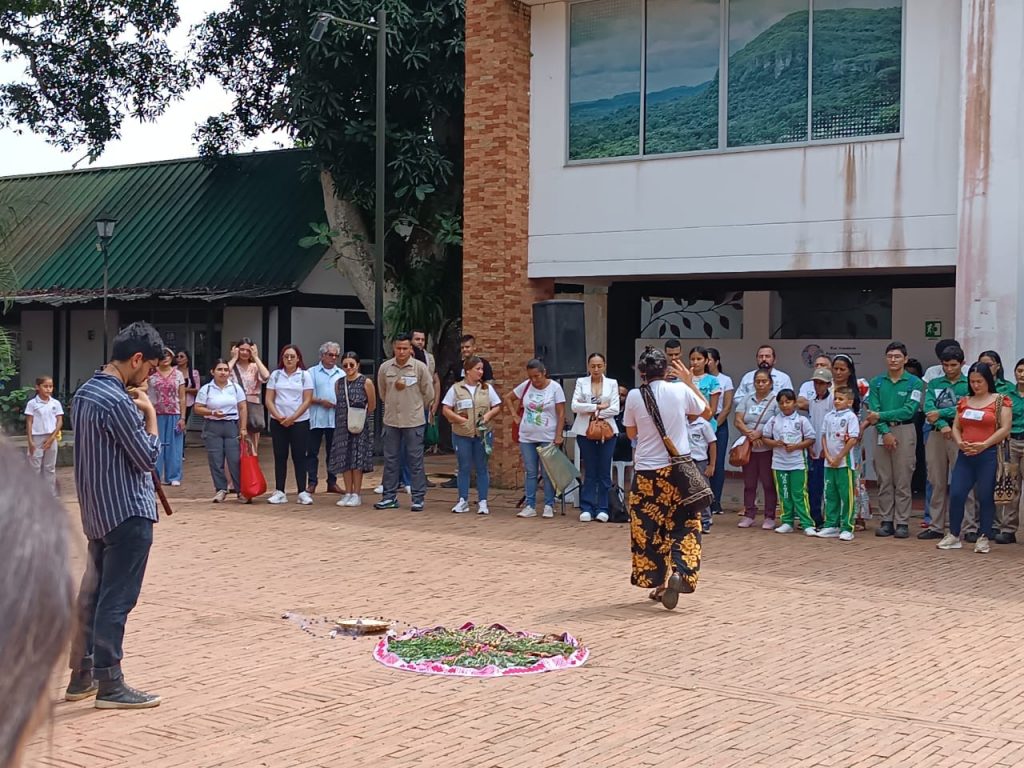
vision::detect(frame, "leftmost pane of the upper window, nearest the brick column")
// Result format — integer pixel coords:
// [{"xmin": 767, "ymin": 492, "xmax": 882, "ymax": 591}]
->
[{"xmin": 569, "ymin": 0, "xmax": 643, "ymax": 160}]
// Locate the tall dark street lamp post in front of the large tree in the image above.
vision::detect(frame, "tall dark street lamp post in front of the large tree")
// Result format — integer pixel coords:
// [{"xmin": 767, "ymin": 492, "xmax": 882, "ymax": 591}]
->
[{"xmin": 309, "ymin": 7, "xmax": 387, "ymax": 444}]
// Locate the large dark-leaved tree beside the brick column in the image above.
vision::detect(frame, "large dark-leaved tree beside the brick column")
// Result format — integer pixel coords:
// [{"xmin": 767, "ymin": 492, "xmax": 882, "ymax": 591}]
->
[{"xmin": 195, "ymin": 0, "xmax": 465, "ymax": 337}]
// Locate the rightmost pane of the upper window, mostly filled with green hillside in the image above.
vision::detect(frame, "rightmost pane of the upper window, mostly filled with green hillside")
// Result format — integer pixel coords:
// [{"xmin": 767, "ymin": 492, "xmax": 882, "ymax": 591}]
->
[{"xmin": 811, "ymin": 0, "xmax": 903, "ymax": 138}]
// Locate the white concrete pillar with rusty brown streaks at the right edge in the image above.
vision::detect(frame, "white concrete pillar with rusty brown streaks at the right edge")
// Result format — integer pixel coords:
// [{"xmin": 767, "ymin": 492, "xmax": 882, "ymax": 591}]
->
[{"xmin": 956, "ymin": 0, "xmax": 1024, "ymax": 360}]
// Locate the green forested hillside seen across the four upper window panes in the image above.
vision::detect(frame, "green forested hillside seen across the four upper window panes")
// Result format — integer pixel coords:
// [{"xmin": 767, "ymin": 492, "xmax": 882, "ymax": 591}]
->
[{"xmin": 569, "ymin": 7, "xmax": 902, "ymax": 159}]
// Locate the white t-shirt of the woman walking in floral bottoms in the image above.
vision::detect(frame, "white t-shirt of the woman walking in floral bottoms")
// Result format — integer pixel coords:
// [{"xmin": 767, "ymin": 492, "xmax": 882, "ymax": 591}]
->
[{"xmin": 623, "ymin": 380, "xmax": 707, "ymax": 470}]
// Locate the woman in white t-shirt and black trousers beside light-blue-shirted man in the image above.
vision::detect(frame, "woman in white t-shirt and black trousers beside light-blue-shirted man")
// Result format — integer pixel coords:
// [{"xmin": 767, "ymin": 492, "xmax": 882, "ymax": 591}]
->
[{"xmin": 266, "ymin": 344, "xmax": 313, "ymax": 504}]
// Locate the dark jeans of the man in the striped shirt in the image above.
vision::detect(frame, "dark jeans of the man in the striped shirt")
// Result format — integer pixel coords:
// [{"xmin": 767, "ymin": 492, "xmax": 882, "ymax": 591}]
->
[{"xmin": 70, "ymin": 517, "xmax": 153, "ymax": 681}]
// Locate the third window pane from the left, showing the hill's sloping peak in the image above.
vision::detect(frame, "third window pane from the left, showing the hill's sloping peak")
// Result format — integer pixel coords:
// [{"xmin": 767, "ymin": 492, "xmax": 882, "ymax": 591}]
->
[{"xmin": 728, "ymin": 0, "xmax": 810, "ymax": 146}]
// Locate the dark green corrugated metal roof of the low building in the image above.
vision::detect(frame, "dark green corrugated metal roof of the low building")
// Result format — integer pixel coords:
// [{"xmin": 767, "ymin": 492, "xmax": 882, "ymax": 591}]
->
[{"xmin": 0, "ymin": 150, "xmax": 325, "ymax": 303}]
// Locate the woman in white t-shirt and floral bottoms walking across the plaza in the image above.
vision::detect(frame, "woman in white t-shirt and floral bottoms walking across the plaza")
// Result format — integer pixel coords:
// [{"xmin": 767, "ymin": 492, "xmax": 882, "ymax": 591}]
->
[{"xmin": 623, "ymin": 347, "xmax": 713, "ymax": 610}]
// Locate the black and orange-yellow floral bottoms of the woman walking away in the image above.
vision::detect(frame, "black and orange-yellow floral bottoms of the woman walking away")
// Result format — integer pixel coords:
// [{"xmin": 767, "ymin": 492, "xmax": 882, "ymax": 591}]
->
[{"xmin": 630, "ymin": 461, "xmax": 711, "ymax": 589}]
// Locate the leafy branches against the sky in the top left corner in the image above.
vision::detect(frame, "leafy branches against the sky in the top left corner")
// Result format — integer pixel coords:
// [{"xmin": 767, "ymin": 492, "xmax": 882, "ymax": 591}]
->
[{"xmin": 0, "ymin": 0, "xmax": 189, "ymax": 157}]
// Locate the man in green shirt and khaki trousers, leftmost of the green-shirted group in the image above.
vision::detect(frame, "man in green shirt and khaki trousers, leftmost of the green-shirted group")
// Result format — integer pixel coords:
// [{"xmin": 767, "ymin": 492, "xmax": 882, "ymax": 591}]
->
[{"xmin": 864, "ymin": 341, "xmax": 925, "ymax": 539}]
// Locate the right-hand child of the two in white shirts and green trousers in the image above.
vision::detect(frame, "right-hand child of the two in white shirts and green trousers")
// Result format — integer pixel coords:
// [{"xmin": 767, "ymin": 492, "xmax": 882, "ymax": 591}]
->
[{"xmin": 818, "ymin": 387, "xmax": 860, "ymax": 542}]
